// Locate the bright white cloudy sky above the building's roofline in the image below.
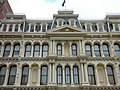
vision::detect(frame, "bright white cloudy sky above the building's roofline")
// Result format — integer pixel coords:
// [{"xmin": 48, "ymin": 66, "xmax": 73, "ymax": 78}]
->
[{"xmin": 8, "ymin": 0, "xmax": 120, "ymax": 19}]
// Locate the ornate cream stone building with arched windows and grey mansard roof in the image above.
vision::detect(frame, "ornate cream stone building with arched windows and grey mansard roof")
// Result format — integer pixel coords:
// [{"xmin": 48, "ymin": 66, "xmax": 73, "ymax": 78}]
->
[{"xmin": 0, "ymin": 11, "xmax": 120, "ymax": 90}]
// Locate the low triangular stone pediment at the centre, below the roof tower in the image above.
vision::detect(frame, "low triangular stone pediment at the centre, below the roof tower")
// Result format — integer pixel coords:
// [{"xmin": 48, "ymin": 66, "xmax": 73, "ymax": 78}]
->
[{"xmin": 48, "ymin": 26, "xmax": 86, "ymax": 32}]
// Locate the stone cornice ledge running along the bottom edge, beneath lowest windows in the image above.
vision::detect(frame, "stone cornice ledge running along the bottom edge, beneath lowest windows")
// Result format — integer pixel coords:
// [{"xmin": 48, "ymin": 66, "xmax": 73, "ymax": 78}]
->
[{"xmin": 0, "ymin": 85, "xmax": 120, "ymax": 90}]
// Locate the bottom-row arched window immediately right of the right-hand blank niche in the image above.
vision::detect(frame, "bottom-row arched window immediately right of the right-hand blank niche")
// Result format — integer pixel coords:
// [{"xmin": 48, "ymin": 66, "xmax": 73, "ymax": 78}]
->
[{"xmin": 107, "ymin": 65, "xmax": 115, "ymax": 84}]
